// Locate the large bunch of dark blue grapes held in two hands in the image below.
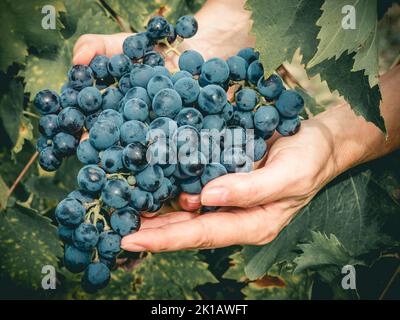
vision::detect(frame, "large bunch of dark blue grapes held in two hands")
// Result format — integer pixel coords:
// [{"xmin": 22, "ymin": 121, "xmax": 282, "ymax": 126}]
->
[{"xmin": 35, "ymin": 16, "xmax": 304, "ymax": 292}]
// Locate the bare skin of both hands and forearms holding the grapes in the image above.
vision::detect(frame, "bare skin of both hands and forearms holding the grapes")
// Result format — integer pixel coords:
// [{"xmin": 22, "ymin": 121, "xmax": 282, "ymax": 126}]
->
[{"xmin": 73, "ymin": 0, "xmax": 400, "ymax": 252}]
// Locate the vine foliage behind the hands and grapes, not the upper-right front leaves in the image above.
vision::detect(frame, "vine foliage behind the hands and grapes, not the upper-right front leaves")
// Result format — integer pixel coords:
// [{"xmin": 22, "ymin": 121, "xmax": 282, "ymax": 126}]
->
[{"xmin": 0, "ymin": 0, "xmax": 400, "ymax": 299}]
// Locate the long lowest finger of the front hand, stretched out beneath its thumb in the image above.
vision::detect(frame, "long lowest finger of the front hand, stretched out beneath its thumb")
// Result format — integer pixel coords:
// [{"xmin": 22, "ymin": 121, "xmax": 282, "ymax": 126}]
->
[{"xmin": 121, "ymin": 208, "xmax": 287, "ymax": 252}]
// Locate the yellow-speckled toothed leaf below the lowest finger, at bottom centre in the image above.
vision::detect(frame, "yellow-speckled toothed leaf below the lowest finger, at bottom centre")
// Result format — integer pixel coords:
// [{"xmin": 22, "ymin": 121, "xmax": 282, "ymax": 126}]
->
[{"xmin": 95, "ymin": 251, "xmax": 217, "ymax": 300}]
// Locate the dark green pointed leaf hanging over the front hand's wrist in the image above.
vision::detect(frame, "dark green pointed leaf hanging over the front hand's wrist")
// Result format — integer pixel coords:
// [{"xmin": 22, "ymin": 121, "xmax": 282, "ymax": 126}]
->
[{"xmin": 307, "ymin": 54, "xmax": 386, "ymax": 132}]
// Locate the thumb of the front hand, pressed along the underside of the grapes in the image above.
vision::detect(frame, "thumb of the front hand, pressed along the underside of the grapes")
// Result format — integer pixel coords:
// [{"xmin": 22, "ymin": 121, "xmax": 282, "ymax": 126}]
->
[{"xmin": 201, "ymin": 163, "xmax": 288, "ymax": 208}]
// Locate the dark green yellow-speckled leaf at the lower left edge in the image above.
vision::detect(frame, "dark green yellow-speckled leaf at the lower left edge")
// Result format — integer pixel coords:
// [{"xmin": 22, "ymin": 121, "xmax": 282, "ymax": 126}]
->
[{"xmin": 0, "ymin": 208, "xmax": 62, "ymax": 289}]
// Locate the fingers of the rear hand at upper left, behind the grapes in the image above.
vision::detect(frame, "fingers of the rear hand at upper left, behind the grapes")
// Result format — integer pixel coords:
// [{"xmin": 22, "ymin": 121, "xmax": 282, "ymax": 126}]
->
[{"xmin": 72, "ymin": 33, "xmax": 131, "ymax": 64}]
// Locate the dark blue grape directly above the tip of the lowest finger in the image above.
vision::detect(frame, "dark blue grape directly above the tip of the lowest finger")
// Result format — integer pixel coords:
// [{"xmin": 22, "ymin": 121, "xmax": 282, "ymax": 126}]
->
[{"xmin": 110, "ymin": 207, "xmax": 140, "ymax": 237}]
